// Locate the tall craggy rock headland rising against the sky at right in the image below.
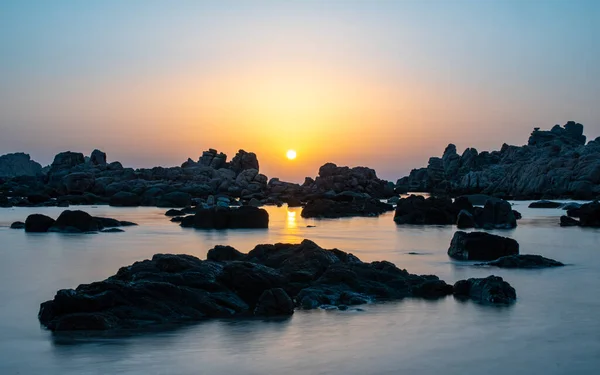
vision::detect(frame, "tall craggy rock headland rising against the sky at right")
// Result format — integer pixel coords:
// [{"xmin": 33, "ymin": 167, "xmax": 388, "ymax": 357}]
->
[{"xmin": 396, "ymin": 121, "xmax": 600, "ymax": 199}]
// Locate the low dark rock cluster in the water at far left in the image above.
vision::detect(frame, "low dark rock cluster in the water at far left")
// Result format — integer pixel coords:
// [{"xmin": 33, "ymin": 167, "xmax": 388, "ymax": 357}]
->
[{"xmin": 11, "ymin": 210, "xmax": 137, "ymax": 233}]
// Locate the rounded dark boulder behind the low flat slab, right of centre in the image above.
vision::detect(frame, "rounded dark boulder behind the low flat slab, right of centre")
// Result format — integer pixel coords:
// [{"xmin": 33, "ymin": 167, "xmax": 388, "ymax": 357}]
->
[{"xmin": 448, "ymin": 231, "xmax": 519, "ymax": 260}]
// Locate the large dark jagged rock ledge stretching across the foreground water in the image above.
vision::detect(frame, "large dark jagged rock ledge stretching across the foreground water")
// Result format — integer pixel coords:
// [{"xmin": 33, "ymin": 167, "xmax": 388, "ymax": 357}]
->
[{"xmin": 38, "ymin": 240, "xmax": 510, "ymax": 331}]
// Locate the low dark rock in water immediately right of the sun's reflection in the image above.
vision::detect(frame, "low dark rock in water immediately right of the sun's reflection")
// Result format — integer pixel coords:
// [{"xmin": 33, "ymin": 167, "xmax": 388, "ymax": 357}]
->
[{"xmin": 301, "ymin": 198, "xmax": 394, "ymax": 218}]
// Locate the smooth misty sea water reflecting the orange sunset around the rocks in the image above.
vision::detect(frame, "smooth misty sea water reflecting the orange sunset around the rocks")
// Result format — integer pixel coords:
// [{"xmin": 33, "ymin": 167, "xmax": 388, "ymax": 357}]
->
[{"xmin": 0, "ymin": 202, "xmax": 600, "ymax": 375}]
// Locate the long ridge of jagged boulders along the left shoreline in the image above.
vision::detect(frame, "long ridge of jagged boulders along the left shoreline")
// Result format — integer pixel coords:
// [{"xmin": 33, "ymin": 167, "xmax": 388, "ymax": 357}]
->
[{"xmin": 0, "ymin": 150, "xmax": 268, "ymax": 207}]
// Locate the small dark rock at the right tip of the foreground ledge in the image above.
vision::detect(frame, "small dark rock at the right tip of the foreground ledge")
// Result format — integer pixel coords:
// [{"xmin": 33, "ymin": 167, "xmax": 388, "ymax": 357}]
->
[{"xmin": 454, "ymin": 276, "xmax": 517, "ymax": 305}]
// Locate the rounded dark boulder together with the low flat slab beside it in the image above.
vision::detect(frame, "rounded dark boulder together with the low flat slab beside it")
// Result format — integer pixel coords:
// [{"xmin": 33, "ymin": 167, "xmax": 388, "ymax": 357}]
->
[{"xmin": 448, "ymin": 231, "xmax": 564, "ymax": 268}]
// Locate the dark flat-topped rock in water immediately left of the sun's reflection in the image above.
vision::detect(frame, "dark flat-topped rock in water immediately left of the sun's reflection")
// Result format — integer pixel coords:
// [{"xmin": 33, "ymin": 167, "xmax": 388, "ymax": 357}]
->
[{"xmin": 181, "ymin": 206, "xmax": 269, "ymax": 229}]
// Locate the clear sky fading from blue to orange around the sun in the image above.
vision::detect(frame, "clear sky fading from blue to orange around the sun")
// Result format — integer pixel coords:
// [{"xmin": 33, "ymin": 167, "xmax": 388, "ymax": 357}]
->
[{"xmin": 0, "ymin": 0, "xmax": 600, "ymax": 182}]
